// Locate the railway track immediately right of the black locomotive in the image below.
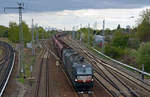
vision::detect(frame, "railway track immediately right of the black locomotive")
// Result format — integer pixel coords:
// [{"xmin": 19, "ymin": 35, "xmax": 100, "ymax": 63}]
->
[{"xmin": 62, "ymin": 37, "xmax": 129, "ymax": 97}]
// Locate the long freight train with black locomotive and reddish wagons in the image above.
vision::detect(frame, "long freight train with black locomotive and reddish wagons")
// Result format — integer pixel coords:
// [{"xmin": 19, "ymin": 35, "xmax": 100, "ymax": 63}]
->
[{"xmin": 52, "ymin": 32, "xmax": 93, "ymax": 92}]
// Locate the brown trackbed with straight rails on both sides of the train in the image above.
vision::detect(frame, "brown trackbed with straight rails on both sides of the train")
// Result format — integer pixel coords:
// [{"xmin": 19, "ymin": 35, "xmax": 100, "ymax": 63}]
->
[{"xmin": 33, "ymin": 33, "xmax": 150, "ymax": 97}]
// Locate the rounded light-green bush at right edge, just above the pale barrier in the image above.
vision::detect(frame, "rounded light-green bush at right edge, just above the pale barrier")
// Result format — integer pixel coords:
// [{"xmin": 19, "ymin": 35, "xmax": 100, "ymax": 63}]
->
[{"xmin": 136, "ymin": 42, "xmax": 150, "ymax": 72}]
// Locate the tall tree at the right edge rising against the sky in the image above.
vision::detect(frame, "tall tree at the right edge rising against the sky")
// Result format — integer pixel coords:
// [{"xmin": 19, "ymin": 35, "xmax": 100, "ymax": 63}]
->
[{"xmin": 136, "ymin": 9, "xmax": 150, "ymax": 42}]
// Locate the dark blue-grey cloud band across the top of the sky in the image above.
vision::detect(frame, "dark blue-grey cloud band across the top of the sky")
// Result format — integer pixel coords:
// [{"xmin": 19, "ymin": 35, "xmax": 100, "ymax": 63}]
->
[{"xmin": 0, "ymin": 0, "xmax": 150, "ymax": 13}]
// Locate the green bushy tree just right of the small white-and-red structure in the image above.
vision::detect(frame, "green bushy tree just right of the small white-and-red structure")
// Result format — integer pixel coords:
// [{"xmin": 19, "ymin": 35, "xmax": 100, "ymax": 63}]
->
[{"xmin": 104, "ymin": 29, "xmax": 129, "ymax": 59}]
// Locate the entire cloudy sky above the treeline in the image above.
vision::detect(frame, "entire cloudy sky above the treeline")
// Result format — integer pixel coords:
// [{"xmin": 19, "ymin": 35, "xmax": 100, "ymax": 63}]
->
[{"xmin": 0, "ymin": 0, "xmax": 150, "ymax": 30}]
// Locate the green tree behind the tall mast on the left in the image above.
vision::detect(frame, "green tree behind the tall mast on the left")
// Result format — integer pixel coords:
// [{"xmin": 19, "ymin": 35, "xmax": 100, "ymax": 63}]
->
[{"xmin": 8, "ymin": 22, "xmax": 32, "ymax": 43}]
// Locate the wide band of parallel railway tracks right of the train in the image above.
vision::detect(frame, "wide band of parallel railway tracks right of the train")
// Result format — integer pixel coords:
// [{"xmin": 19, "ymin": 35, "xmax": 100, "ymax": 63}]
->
[{"xmin": 63, "ymin": 35, "xmax": 150, "ymax": 97}]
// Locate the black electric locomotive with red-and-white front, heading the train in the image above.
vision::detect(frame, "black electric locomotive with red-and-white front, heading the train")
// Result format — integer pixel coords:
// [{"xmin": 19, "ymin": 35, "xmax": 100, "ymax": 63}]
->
[{"xmin": 62, "ymin": 49, "xmax": 93, "ymax": 92}]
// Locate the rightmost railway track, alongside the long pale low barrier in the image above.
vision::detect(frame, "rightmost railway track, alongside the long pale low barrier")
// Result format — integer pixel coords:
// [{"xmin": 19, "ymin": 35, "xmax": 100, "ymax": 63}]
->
[{"xmin": 82, "ymin": 45, "xmax": 150, "ymax": 97}]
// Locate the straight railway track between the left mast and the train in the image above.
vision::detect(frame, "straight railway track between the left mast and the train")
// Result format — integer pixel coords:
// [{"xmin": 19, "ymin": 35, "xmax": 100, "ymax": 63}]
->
[{"xmin": 33, "ymin": 42, "xmax": 50, "ymax": 97}]
